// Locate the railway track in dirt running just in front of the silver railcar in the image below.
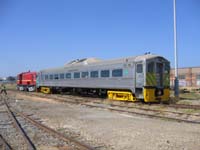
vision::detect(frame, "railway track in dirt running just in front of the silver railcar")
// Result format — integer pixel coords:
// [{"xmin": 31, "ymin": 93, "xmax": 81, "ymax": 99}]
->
[{"xmin": 8, "ymin": 93, "xmax": 200, "ymax": 124}]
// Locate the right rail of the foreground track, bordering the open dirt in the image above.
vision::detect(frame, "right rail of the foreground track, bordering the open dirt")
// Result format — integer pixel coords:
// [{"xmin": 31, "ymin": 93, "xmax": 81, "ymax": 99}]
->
[{"xmin": 12, "ymin": 108, "xmax": 94, "ymax": 150}]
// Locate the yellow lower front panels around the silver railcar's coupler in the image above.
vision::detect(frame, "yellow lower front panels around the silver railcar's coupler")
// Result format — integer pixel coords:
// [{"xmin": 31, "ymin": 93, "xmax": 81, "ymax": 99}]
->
[{"xmin": 143, "ymin": 87, "xmax": 170, "ymax": 103}]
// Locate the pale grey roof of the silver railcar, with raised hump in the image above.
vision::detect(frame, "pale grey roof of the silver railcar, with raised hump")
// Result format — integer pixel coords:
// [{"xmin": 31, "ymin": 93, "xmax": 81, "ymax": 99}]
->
[{"xmin": 41, "ymin": 54, "xmax": 167, "ymax": 72}]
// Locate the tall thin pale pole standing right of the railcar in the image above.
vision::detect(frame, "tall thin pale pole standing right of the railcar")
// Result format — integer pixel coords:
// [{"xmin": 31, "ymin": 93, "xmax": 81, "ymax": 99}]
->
[{"xmin": 173, "ymin": 0, "xmax": 179, "ymax": 99}]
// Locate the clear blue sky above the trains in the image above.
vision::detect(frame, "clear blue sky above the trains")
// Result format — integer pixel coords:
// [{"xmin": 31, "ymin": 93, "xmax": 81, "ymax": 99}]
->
[{"xmin": 0, "ymin": 0, "xmax": 200, "ymax": 77}]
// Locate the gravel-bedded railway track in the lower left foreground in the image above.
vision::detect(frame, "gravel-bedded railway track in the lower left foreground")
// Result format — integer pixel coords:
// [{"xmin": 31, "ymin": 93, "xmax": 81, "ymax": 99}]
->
[{"xmin": 0, "ymin": 96, "xmax": 94, "ymax": 150}]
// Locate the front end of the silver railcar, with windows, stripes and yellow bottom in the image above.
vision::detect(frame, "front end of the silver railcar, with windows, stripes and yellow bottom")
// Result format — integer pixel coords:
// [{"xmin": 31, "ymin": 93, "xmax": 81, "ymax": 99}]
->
[{"xmin": 143, "ymin": 57, "xmax": 170, "ymax": 102}]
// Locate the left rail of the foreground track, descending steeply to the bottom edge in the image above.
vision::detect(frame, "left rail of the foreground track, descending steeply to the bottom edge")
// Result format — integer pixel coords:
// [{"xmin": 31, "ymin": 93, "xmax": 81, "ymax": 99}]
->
[{"xmin": 3, "ymin": 98, "xmax": 36, "ymax": 150}]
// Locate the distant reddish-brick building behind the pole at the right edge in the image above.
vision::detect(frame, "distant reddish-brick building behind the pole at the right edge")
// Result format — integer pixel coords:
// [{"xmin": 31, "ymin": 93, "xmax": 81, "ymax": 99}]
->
[{"xmin": 170, "ymin": 67, "xmax": 200, "ymax": 87}]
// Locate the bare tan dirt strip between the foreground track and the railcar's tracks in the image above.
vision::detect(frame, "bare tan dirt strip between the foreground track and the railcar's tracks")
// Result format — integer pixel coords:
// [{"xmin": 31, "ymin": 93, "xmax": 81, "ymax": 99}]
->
[{"xmin": 9, "ymin": 94, "xmax": 200, "ymax": 150}]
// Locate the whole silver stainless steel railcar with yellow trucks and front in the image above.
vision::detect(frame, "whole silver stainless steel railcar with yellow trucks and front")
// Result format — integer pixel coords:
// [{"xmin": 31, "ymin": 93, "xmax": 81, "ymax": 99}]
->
[{"xmin": 37, "ymin": 54, "xmax": 170, "ymax": 102}]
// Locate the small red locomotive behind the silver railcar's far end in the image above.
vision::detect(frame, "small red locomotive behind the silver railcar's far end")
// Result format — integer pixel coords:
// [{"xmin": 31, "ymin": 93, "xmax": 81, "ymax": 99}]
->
[{"xmin": 17, "ymin": 71, "xmax": 37, "ymax": 92}]
